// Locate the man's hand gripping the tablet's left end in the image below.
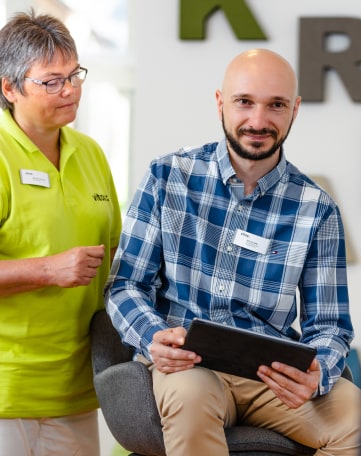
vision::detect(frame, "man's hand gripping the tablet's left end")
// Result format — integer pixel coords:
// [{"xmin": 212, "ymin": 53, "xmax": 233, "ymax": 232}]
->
[{"xmin": 150, "ymin": 326, "xmax": 201, "ymax": 374}]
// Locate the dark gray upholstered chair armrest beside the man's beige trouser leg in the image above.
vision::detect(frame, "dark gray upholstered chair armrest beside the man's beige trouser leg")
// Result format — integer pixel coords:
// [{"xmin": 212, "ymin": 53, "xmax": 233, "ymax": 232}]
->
[{"xmin": 94, "ymin": 361, "xmax": 165, "ymax": 456}]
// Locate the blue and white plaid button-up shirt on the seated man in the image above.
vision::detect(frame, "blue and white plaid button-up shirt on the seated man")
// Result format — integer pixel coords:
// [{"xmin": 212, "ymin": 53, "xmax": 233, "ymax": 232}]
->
[{"xmin": 107, "ymin": 140, "xmax": 353, "ymax": 394}]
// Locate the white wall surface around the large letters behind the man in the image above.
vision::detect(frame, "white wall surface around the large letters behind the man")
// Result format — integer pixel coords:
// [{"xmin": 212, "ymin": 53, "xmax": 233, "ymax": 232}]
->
[{"xmin": 130, "ymin": 0, "xmax": 361, "ymax": 347}]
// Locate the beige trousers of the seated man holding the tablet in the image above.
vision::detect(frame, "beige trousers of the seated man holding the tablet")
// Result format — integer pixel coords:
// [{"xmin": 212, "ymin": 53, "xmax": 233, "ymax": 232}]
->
[{"xmin": 150, "ymin": 366, "xmax": 361, "ymax": 456}]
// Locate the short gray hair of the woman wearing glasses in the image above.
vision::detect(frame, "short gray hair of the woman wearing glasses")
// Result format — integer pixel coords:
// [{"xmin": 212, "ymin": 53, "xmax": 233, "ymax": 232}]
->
[{"xmin": 0, "ymin": 8, "xmax": 78, "ymax": 109}]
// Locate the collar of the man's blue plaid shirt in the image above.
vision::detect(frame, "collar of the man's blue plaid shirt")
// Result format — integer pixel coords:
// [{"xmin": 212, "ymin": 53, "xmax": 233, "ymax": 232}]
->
[{"xmin": 216, "ymin": 138, "xmax": 287, "ymax": 195}]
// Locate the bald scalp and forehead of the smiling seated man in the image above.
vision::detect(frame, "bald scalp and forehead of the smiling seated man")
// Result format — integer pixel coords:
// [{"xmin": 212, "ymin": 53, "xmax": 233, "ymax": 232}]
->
[{"xmin": 222, "ymin": 49, "xmax": 298, "ymax": 102}]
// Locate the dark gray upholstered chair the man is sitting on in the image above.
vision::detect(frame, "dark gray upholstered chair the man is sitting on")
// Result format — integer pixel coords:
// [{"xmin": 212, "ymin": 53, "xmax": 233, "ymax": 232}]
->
[{"xmin": 91, "ymin": 310, "xmax": 352, "ymax": 456}]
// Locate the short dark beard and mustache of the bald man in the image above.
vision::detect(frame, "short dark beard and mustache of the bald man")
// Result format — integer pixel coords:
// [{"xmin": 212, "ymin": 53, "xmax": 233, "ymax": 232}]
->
[{"xmin": 222, "ymin": 113, "xmax": 293, "ymax": 161}]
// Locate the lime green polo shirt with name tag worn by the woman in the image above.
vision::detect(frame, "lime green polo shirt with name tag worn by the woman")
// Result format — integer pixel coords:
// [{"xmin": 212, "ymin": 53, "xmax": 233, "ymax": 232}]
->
[{"xmin": 0, "ymin": 111, "xmax": 121, "ymax": 418}]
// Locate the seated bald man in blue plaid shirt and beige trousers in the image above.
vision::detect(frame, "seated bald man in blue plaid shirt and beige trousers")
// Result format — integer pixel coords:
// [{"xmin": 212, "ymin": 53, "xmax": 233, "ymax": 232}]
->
[{"xmin": 107, "ymin": 49, "xmax": 361, "ymax": 456}]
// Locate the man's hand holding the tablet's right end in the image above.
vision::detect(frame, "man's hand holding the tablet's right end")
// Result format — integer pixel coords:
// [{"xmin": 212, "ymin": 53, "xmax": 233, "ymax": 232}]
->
[{"xmin": 257, "ymin": 358, "xmax": 321, "ymax": 408}]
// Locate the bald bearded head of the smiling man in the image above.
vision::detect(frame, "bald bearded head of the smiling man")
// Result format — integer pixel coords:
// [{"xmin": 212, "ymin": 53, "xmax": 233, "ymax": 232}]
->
[{"xmin": 216, "ymin": 49, "xmax": 301, "ymax": 169}]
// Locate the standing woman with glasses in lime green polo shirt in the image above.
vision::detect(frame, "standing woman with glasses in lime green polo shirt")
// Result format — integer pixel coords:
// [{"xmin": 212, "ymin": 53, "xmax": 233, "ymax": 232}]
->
[{"xmin": 0, "ymin": 10, "xmax": 121, "ymax": 456}]
